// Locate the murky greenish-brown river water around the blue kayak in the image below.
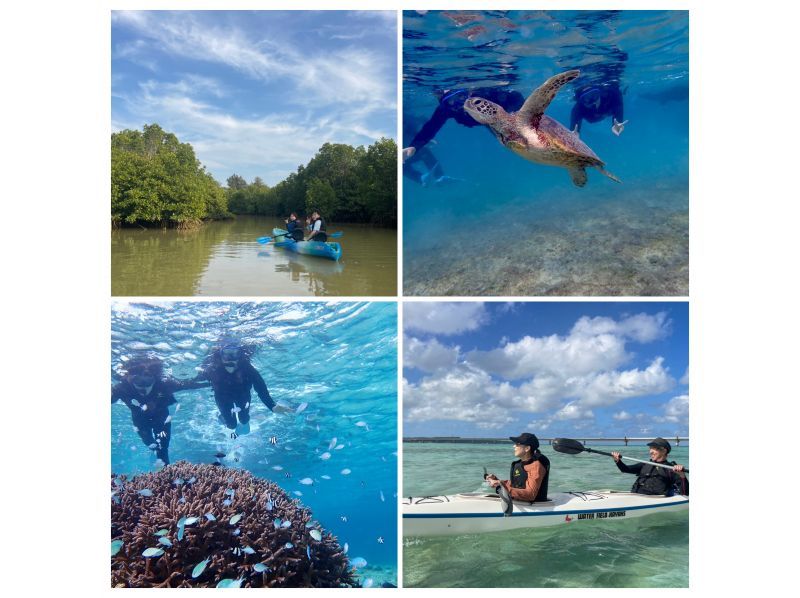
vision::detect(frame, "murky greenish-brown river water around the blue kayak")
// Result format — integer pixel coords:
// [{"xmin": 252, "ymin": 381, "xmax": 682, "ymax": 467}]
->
[{"xmin": 111, "ymin": 216, "xmax": 397, "ymax": 297}]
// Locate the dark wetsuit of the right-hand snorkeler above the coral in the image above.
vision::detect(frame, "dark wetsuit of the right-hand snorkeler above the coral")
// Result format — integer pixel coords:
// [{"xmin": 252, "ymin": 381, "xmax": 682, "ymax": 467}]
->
[{"xmin": 196, "ymin": 359, "xmax": 275, "ymax": 430}]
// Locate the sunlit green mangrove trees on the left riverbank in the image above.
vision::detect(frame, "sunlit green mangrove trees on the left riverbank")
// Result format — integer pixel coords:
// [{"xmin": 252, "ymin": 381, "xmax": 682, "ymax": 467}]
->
[{"xmin": 111, "ymin": 124, "xmax": 230, "ymax": 226}]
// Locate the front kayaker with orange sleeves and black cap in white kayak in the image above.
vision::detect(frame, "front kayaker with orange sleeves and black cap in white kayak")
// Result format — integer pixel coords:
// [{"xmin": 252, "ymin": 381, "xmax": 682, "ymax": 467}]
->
[{"xmin": 486, "ymin": 432, "xmax": 550, "ymax": 502}]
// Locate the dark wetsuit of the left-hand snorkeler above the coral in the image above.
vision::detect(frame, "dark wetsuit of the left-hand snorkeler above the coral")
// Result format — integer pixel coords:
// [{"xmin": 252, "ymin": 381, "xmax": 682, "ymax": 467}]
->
[{"xmin": 111, "ymin": 378, "xmax": 208, "ymax": 464}]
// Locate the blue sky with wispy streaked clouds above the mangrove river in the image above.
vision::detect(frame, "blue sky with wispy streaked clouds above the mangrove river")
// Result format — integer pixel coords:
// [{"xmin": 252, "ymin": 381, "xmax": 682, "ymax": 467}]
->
[{"xmin": 111, "ymin": 11, "xmax": 397, "ymax": 185}]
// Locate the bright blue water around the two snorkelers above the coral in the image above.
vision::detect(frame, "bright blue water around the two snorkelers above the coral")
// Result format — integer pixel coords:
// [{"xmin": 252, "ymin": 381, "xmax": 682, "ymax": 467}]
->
[{"xmin": 111, "ymin": 302, "xmax": 397, "ymax": 586}]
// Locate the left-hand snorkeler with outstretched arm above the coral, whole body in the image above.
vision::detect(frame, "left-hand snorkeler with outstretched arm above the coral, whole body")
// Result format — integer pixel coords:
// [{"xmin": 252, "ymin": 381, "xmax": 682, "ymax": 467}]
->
[{"xmin": 111, "ymin": 357, "xmax": 208, "ymax": 465}]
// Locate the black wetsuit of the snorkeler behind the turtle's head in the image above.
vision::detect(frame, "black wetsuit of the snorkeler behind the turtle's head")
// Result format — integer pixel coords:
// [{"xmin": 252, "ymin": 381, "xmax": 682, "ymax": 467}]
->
[{"xmin": 410, "ymin": 87, "xmax": 525, "ymax": 152}]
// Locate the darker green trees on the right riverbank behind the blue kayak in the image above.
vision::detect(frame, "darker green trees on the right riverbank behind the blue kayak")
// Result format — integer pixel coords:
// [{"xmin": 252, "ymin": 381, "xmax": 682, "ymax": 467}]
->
[{"xmin": 223, "ymin": 138, "xmax": 397, "ymax": 226}]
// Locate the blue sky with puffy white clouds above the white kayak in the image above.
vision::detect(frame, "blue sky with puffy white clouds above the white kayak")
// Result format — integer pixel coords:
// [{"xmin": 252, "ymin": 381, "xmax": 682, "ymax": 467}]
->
[{"xmin": 403, "ymin": 302, "xmax": 689, "ymax": 437}]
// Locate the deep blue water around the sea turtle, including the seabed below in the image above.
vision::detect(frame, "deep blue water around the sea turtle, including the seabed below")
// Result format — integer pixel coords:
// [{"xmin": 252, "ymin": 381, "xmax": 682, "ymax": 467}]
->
[{"xmin": 403, "ymin": 11, "xmax": 689, "ymax": 296}]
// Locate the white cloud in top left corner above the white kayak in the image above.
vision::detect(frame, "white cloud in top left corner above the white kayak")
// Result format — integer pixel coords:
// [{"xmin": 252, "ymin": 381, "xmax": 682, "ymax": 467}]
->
[{"xmin": 403, "ymin": 301, "xmax": 489, "ymax": 335}]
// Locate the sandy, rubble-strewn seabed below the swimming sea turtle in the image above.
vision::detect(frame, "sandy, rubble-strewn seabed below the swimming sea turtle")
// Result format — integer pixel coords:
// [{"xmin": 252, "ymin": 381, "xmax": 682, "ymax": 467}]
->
[{"xmin": 403, "ymin": 188, "xmax": 689, "ymax": 297}]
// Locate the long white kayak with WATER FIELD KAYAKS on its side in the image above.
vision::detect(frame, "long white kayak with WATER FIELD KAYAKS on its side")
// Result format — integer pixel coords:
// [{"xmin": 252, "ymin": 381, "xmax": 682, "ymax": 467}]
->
[{"xmin": 403, "ymin": 490, "xmax": 689, "ymax": 536}]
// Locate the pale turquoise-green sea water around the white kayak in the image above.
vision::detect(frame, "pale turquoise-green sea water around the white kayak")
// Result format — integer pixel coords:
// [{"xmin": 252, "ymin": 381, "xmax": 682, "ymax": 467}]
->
[{"xmin": 403, "ymin": 443, "xmax": 689, "ymax": 587}]
